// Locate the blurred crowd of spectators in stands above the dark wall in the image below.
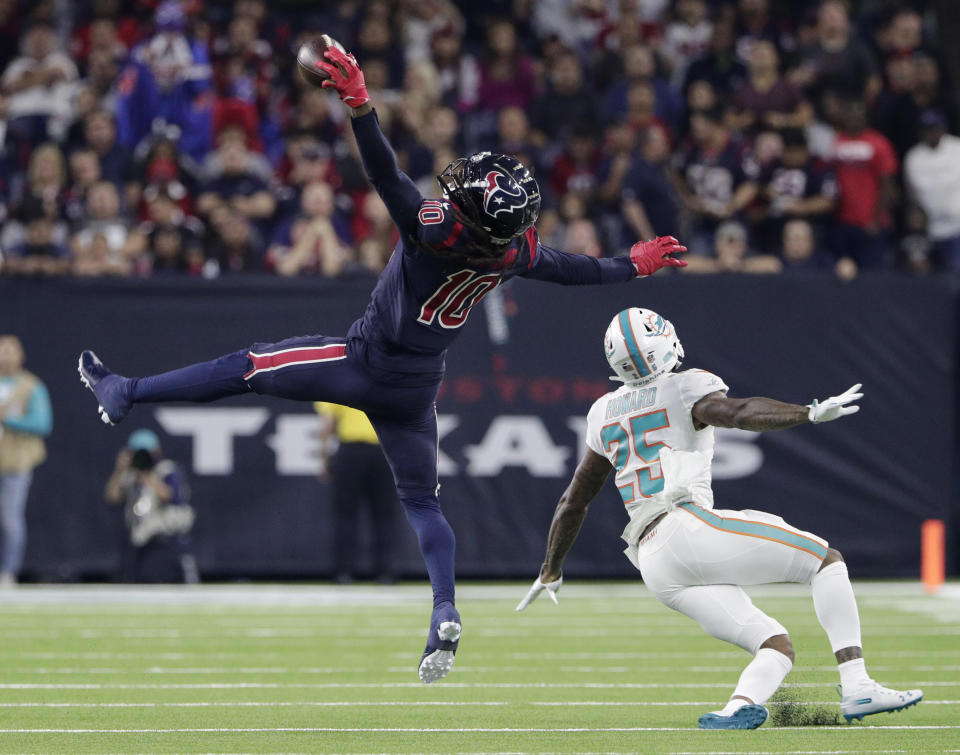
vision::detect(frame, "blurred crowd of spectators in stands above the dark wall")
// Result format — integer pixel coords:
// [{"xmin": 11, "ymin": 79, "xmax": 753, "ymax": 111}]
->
[{"xmin": 0, "ymin": 0, "xmax": 960, "ymax": 277}]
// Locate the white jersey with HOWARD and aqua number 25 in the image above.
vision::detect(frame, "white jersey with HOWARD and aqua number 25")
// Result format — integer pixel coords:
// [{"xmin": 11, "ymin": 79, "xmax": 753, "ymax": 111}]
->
[{"xmin": 587, "ymin": 370, "xmax": 728, "ymax": 539}]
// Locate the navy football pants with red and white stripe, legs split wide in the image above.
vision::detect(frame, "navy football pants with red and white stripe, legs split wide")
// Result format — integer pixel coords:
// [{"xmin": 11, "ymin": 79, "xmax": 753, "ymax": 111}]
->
[{"xmin": 132, "ymin": 336, "xmax": 455, "ymax": 605}]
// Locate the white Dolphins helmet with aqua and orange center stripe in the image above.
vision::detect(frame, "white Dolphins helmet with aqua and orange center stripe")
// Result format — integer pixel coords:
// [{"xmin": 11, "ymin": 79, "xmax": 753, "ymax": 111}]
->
[{"xmin": 603, "ymin": 307, "xmax": 683, "ymax": 385}]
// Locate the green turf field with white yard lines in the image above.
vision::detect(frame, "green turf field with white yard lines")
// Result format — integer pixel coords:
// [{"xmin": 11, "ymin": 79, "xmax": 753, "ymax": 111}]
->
[{"xmin": 0, "ymin": 583, "xmax": 960, "ymax": 754}]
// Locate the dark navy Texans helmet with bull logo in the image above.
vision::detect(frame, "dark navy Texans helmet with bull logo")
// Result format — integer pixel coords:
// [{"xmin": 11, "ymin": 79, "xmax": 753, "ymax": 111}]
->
[{"xmin": 437, "ymin": 152, "xmax": 540, "ymax": 247}]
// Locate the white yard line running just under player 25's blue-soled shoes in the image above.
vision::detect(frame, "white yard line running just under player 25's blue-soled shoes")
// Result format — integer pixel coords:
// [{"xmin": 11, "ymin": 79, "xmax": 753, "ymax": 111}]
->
[{"xmin": 0, "ymin": 724, "xmax": 960, "ymax": 736}]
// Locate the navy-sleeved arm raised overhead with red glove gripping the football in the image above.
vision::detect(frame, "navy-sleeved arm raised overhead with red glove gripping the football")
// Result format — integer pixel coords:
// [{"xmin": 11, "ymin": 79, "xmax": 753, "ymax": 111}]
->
[{"xmin": 320, "ymin": 47, "xmax": 423, "ymax": 235}]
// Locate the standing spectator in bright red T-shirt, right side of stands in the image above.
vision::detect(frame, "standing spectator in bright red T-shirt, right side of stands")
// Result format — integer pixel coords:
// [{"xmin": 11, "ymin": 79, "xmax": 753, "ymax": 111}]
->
[{"xmin": 834, "ymin": 100, "xmax": 899, "ymax": 268}]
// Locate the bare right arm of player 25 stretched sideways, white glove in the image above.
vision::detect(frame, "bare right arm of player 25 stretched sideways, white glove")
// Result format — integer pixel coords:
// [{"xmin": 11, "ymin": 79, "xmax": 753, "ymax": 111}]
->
[{"xmin": 691, "ymin": 383, "xmax": 863, "ymax": 432}]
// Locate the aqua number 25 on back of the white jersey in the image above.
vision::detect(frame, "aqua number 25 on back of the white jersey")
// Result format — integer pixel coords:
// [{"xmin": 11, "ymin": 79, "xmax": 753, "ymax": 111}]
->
[{"xmin": 600, "ymin": 409, "xmax": 670, "ymax": 504}]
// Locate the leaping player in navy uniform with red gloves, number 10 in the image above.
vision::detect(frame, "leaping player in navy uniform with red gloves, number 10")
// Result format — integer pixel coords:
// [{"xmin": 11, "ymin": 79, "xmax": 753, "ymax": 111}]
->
[{"xmin": 79, "ymin": 47, "xmax": 686, "ymax": 682}]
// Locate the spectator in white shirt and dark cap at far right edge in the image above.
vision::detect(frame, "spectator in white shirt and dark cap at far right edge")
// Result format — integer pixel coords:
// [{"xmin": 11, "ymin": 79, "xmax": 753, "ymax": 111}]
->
[{"xmin": 904, "ymin": 110, "xmax": 960, "ymax": 271}]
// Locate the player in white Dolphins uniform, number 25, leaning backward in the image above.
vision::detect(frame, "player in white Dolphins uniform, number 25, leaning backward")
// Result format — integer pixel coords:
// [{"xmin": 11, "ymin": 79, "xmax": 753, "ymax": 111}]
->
[{"xmin": 517, "ymin": 307, "xmax": 923, "ymax": 729}]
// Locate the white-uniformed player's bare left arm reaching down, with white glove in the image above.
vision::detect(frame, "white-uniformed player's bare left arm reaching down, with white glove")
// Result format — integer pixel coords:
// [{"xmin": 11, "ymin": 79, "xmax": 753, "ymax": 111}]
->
[{"xmin": 517, "ymin": 448, "xmax": 613, "ymax": 611}]
